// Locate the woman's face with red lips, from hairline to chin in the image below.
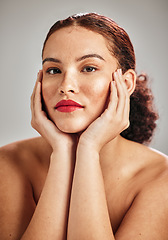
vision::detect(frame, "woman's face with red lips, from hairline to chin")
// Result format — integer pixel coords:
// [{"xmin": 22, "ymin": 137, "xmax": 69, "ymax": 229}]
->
[{"xmin": 42, "ymin": 26, "xmax": 117, "ymax": 133}]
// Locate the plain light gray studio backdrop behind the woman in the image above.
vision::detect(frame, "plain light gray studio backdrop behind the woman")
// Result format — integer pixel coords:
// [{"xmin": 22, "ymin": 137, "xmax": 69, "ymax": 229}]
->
[{"xmin": 0, "ymin": 0, "xmax": 168, "ymax": 154}]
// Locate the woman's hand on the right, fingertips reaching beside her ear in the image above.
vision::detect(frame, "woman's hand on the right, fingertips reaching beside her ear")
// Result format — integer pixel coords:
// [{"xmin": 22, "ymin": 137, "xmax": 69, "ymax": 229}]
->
[{"xmin": 79, "ymin": 69, "xmax": 130, "ymax": 151}]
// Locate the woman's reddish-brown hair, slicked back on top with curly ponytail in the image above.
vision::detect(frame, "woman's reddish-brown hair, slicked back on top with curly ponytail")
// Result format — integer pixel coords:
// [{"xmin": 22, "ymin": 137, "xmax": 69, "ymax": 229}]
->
[{"xmin": 42, "ymin": 13, "xmax": 158, "ymax": 144}]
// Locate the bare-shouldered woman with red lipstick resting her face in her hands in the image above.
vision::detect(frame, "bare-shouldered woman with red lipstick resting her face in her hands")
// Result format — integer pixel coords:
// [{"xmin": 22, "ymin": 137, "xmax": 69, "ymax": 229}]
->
[{"xmin": 0, "ymin": 13, "xmax": 168, "ymax": 240}]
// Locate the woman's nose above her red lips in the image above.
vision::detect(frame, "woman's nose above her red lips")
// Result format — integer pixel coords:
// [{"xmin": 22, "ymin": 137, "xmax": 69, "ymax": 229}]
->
[{"xmin": 58, "ymin": 72, "xmax": 79, "ymax": 94}]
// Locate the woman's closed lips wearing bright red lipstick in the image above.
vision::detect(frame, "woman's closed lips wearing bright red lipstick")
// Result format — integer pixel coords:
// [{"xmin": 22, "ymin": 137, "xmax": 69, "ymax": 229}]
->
[{"xmin": 55, "ymin": 100, "xmax": 83, "ymax": 112}]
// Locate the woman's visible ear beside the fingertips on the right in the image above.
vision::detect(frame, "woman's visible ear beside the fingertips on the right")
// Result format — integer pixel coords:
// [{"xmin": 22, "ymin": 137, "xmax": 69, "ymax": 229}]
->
[{"xmin": 123, "ymin": 69, "xmax": 137, "ymax": 95}]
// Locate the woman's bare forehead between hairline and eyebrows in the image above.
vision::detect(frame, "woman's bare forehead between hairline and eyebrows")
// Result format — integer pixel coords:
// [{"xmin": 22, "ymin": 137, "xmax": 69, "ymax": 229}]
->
[{"xmin": 43, "ymin": 26, "xmax": 111, "ymax": 58}]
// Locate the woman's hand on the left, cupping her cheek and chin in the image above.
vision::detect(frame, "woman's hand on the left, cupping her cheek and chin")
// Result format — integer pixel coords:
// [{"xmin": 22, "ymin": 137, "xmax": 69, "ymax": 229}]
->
[{"xmin": 31, "ymin": 70, "xmax": 77, "ymax": 150}]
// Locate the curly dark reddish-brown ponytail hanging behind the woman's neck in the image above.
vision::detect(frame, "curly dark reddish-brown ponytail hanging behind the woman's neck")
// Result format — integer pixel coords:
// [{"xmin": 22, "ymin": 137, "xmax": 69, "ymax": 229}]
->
[{"xmin": 121, "ymin": 73, "xmax": 158, "ymax": 144}]
